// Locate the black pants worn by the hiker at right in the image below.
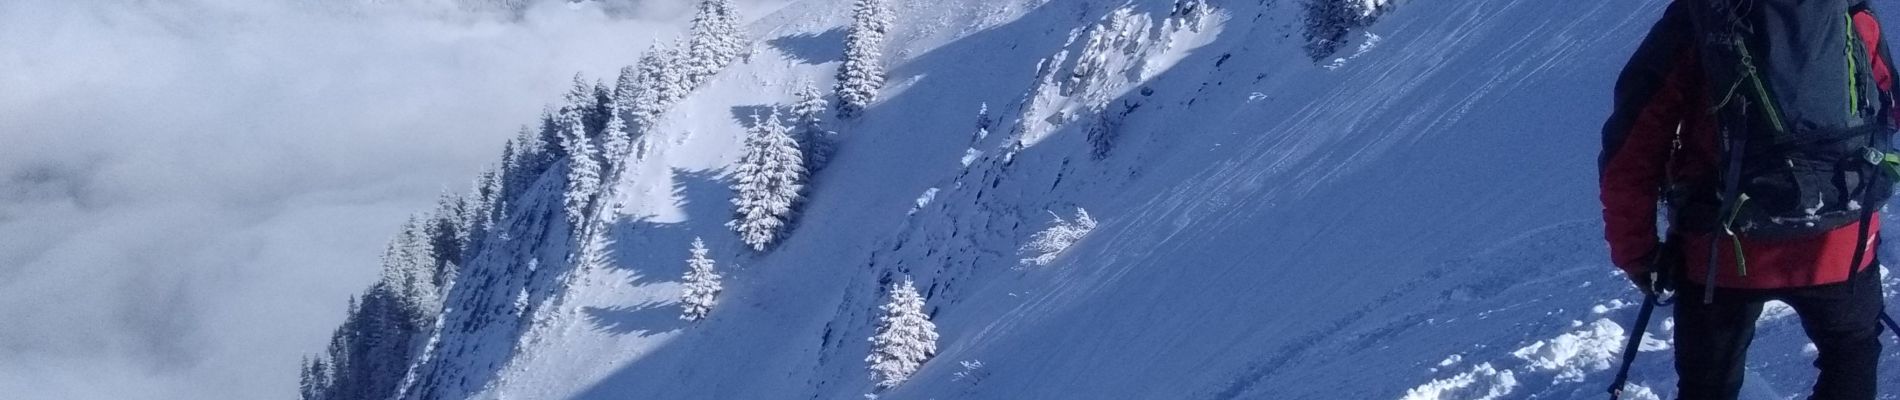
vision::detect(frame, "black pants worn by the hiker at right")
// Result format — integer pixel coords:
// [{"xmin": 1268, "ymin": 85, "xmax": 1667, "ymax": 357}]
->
[{"xmin": 1676, "ymin": 267, "xmax": 1883, "ymax": 400}]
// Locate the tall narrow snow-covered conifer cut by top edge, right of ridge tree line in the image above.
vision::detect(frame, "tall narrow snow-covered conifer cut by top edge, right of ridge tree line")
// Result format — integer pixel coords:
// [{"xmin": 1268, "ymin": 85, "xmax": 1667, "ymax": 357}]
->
[{"xmin": 838, "ymin": 0, "xmax": 891, "ymax": 119}]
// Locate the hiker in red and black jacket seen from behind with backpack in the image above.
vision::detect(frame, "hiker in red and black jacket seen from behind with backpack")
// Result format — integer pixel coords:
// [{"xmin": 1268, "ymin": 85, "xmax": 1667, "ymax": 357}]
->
[{"xmin": 1598, "ymin": 0, "xmax": 1900, "ymax": 400}]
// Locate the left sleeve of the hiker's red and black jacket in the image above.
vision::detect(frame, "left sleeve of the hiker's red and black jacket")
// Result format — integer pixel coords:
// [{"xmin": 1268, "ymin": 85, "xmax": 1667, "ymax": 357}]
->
[{"xmin": 1598, "ymin": 6, "xmax": 1699, "ymax": 271}]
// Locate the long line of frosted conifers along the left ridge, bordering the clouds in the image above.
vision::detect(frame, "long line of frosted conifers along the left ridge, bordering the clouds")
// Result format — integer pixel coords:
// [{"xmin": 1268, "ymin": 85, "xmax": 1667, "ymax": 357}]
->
[{"xmin": 298, "ymin": 0, "xmax": 751, "ymax": 400}]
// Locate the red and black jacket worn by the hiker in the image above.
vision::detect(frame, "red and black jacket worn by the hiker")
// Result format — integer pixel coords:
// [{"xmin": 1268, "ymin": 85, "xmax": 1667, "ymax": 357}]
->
[{"xmin": 1598, "ymin": 2, "xmax": 1892, "ymax": 288}]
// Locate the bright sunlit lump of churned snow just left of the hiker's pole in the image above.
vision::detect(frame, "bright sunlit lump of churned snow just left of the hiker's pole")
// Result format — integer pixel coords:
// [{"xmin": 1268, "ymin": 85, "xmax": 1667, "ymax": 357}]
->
[{"xmin": 1511, "ymin": 318, "xmax": 1623, "ymax": 383}]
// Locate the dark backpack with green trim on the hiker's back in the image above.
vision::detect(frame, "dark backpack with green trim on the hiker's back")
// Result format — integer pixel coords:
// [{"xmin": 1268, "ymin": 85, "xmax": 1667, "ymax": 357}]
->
[{"xmin": 1685, "ymin": 0, "xmax": 1900, "ymax": 240}]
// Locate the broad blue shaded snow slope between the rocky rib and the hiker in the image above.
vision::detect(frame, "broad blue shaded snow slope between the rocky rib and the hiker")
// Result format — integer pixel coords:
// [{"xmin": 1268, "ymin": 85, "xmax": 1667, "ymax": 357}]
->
[{"xmin": 870, "ymin": 0, "xmax": 1900, "ymax": 398}]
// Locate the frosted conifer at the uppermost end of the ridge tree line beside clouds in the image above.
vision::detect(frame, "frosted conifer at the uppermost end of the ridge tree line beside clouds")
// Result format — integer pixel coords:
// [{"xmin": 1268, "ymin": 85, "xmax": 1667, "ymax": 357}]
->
[{"xmin": 686, "ymin": 0, "xmax": 752, "ymax": 87}]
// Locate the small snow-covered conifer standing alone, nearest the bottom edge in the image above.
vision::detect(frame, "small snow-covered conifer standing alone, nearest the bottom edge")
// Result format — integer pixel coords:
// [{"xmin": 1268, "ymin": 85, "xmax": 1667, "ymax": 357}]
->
[{"xmin": 865, "ymin": 277, "xmax": 937, "ymax": 389}]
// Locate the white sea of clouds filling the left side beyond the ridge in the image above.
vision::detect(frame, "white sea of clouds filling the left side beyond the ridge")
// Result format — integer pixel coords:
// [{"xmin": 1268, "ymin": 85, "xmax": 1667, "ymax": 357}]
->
[{"xmin": 0, "ymin": 0, "xmax": 771, "ymax": 398}]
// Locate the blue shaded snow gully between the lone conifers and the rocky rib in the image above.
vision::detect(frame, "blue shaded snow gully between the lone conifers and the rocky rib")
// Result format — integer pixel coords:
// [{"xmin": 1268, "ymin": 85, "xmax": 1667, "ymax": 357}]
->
[{"xmin": 551, "ymin": 2, "xmax": 1210, "ymax": 398}]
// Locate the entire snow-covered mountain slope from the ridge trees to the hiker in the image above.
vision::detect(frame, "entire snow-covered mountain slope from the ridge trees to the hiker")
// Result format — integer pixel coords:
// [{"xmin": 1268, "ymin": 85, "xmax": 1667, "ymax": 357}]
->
[{"xmin": 370, "ymin": 0, "xmax": 1900, "ymax": 398}]
